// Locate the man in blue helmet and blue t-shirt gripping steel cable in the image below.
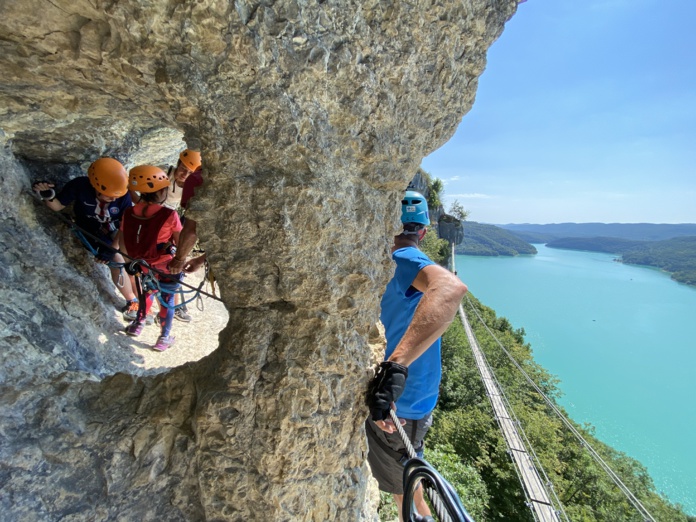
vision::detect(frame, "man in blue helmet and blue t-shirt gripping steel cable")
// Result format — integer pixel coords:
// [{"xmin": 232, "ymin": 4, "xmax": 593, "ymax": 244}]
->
[{"xmin": 365, "ymin": 190, "xmax": 467, "ymax": 520}]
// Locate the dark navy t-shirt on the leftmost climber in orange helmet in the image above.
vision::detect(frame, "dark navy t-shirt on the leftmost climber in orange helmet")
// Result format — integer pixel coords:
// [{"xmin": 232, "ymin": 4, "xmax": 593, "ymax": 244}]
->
[{"xmin": 57, "ymin": 176, "xmax": 132, "ymax": 238}]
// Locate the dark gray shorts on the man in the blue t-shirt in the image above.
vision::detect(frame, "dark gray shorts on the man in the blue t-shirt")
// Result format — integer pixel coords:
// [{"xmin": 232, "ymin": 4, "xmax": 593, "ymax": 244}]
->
[{"xmin": 365, "ymin": 413, "xmax": 433, "ymax": 495}]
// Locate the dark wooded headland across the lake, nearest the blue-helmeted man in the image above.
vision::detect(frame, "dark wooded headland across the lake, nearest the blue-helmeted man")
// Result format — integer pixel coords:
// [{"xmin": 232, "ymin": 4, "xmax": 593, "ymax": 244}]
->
[{"xmin": 455, "ymin": 221, "xmax": 536, "ymax": 256}]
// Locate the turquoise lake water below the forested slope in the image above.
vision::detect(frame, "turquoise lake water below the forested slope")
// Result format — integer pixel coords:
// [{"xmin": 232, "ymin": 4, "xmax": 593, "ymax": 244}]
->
[{"xmin": 456, "ymin": 245, "xmax": 696, "ymax": 515}]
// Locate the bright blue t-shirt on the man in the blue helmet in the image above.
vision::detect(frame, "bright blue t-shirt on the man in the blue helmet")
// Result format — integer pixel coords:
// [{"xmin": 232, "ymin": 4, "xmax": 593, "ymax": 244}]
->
[{"xmin": 380, "ymin": 247, "xmax": 442, "ymax": 419}]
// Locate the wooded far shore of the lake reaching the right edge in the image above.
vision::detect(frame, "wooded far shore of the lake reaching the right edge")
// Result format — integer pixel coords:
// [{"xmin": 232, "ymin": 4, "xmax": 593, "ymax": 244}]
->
[{"xmin": 547, "ymin": 237, "xmax": 696, "ymax": 285}]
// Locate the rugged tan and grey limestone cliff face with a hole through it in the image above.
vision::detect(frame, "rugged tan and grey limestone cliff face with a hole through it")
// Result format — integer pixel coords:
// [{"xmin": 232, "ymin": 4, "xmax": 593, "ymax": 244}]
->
[{"xmin": 0, "ymin": 0, "xmax": 517, "ymax": 521}]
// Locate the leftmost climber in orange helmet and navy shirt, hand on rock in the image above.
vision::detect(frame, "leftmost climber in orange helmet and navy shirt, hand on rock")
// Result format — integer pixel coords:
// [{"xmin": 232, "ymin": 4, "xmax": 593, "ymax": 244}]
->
[{"xmin": 32, "ymin": 158, "xmax": 138, "ymax": 319}]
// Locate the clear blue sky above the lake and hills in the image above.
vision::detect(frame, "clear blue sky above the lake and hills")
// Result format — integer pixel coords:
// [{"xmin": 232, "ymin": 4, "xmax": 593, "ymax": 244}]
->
[{"xmin": 422, "ymin": 0, "xmax": 696, "ymax": 224}]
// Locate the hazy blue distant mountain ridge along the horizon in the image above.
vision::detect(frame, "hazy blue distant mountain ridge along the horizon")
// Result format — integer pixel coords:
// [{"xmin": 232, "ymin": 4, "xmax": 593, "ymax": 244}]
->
[{"xmin": 495, "ymin": 223, "xmax": 696, "ymax": 243}]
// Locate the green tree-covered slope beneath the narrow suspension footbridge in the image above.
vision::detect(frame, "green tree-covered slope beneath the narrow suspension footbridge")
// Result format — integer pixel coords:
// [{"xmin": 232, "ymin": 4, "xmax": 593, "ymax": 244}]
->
[{"xmin": 383, "ymin": 297, "xmax": 696, "ymax": 522}]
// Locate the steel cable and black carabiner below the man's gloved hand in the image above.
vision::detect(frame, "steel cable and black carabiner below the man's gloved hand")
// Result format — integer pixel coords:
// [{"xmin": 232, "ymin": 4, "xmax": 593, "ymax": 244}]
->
[{"xmin": 389, "ymin": 408, "xmax": 473, "ymax": 522}]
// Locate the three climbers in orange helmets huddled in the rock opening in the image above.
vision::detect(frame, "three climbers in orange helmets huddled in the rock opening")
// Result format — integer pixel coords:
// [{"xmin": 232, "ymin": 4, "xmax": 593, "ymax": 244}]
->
[{"xmin": 32, "ymin": 149, "xmax": 203, "ymax": 351}]
